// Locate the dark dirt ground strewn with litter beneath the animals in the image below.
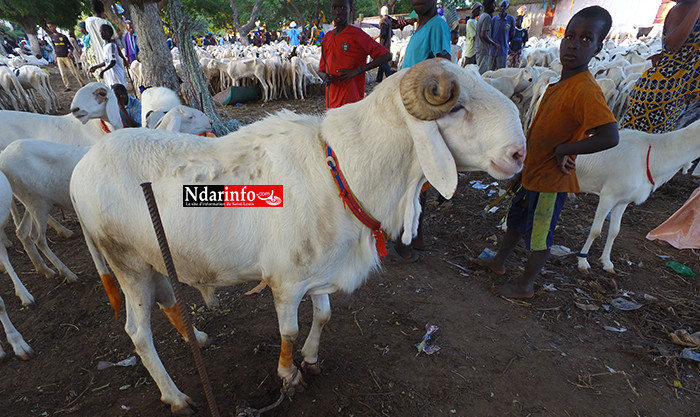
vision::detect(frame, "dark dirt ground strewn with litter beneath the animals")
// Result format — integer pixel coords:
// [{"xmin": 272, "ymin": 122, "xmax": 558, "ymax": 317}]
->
[{"xmin": 0, "ymin": 68, "xmax": 700, "ymax": 417}]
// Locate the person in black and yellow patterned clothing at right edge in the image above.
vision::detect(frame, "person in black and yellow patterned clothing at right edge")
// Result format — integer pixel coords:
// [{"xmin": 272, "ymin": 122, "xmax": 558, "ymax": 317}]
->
[{"xmin": 621, "ymin": 0, "xmax": 700, "ymax": 133}]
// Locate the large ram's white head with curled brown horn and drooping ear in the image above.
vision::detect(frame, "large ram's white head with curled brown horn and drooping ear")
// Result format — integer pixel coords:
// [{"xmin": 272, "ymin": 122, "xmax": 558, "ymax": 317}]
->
[{"xmin": 399, "ymin": 59, "xmax": 525, "ymax": 198}]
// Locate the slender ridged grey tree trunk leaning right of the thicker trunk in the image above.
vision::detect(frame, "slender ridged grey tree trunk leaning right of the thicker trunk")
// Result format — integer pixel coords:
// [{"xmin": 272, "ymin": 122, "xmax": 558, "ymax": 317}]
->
[{"xmin": 168, "ymin": 0, "xmax": 232, "ymax": 136}]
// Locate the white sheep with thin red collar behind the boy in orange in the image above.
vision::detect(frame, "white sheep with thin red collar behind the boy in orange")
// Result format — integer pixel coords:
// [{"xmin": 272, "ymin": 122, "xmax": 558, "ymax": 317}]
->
[{"xmin": 576, "ymin": 121, "xmax": 700, "ymax": 272}]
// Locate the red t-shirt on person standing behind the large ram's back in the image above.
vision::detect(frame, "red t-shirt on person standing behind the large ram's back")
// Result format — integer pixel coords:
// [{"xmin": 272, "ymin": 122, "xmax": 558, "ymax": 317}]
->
[{"xmin": 318, "ymin": 25, "xmax": 389, "ymax": 109}]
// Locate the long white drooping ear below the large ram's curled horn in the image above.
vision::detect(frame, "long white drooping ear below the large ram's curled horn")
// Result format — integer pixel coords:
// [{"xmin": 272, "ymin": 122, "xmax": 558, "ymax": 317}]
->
[{"xmin": 406, "ymin": 117, "xmax": 457, "ymax": 199}]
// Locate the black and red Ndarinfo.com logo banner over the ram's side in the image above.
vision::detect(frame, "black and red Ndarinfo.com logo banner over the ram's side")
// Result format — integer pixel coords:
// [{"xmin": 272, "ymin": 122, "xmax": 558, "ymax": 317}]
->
[{"xmin": 182, "ymin": 185, "xmax": 284, "ymax": 207}]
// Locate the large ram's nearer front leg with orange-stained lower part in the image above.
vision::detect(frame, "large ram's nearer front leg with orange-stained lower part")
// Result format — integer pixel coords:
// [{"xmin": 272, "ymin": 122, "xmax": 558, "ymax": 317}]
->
[{"xmin": 272, "ymin": 289, "xmax": 304, "ymax": 396}]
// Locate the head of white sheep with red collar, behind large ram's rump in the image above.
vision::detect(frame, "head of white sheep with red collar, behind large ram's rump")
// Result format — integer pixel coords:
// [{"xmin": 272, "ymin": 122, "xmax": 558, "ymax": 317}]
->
[{"xmin": 71, "ymin": 83, "xmax": 123, "ymax": 129}]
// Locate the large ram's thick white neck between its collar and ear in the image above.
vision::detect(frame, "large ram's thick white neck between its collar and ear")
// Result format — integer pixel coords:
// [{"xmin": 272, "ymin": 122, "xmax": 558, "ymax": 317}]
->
[{"xmin": 322, "ymin": 96, "xmax": 424, "ymax": 237}]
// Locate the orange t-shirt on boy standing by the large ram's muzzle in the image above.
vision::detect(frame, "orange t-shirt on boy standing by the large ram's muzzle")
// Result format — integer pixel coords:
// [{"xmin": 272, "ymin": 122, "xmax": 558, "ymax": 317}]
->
[{"xmin": 522, "ymin": 71, "xmax": 616, "ymax": 193}]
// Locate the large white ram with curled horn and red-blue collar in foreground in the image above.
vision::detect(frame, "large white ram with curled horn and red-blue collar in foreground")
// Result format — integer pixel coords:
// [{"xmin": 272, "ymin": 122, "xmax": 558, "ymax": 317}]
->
[{"xmin": 71, "ymin": 59, "xmax": 525, "ymax": 413}]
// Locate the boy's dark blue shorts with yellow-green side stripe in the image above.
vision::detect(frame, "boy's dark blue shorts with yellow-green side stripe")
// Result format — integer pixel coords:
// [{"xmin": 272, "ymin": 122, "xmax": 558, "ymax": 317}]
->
[{"xmin": 506, "ymin": 187, "xmax": 566, "ymax": 251}]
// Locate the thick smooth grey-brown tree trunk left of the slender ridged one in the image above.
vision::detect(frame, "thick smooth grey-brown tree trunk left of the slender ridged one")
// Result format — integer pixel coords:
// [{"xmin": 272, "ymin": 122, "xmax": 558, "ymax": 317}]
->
[{"xmin": 129, "ymin": 3, "xmax": 179, "ymax": 91}]
